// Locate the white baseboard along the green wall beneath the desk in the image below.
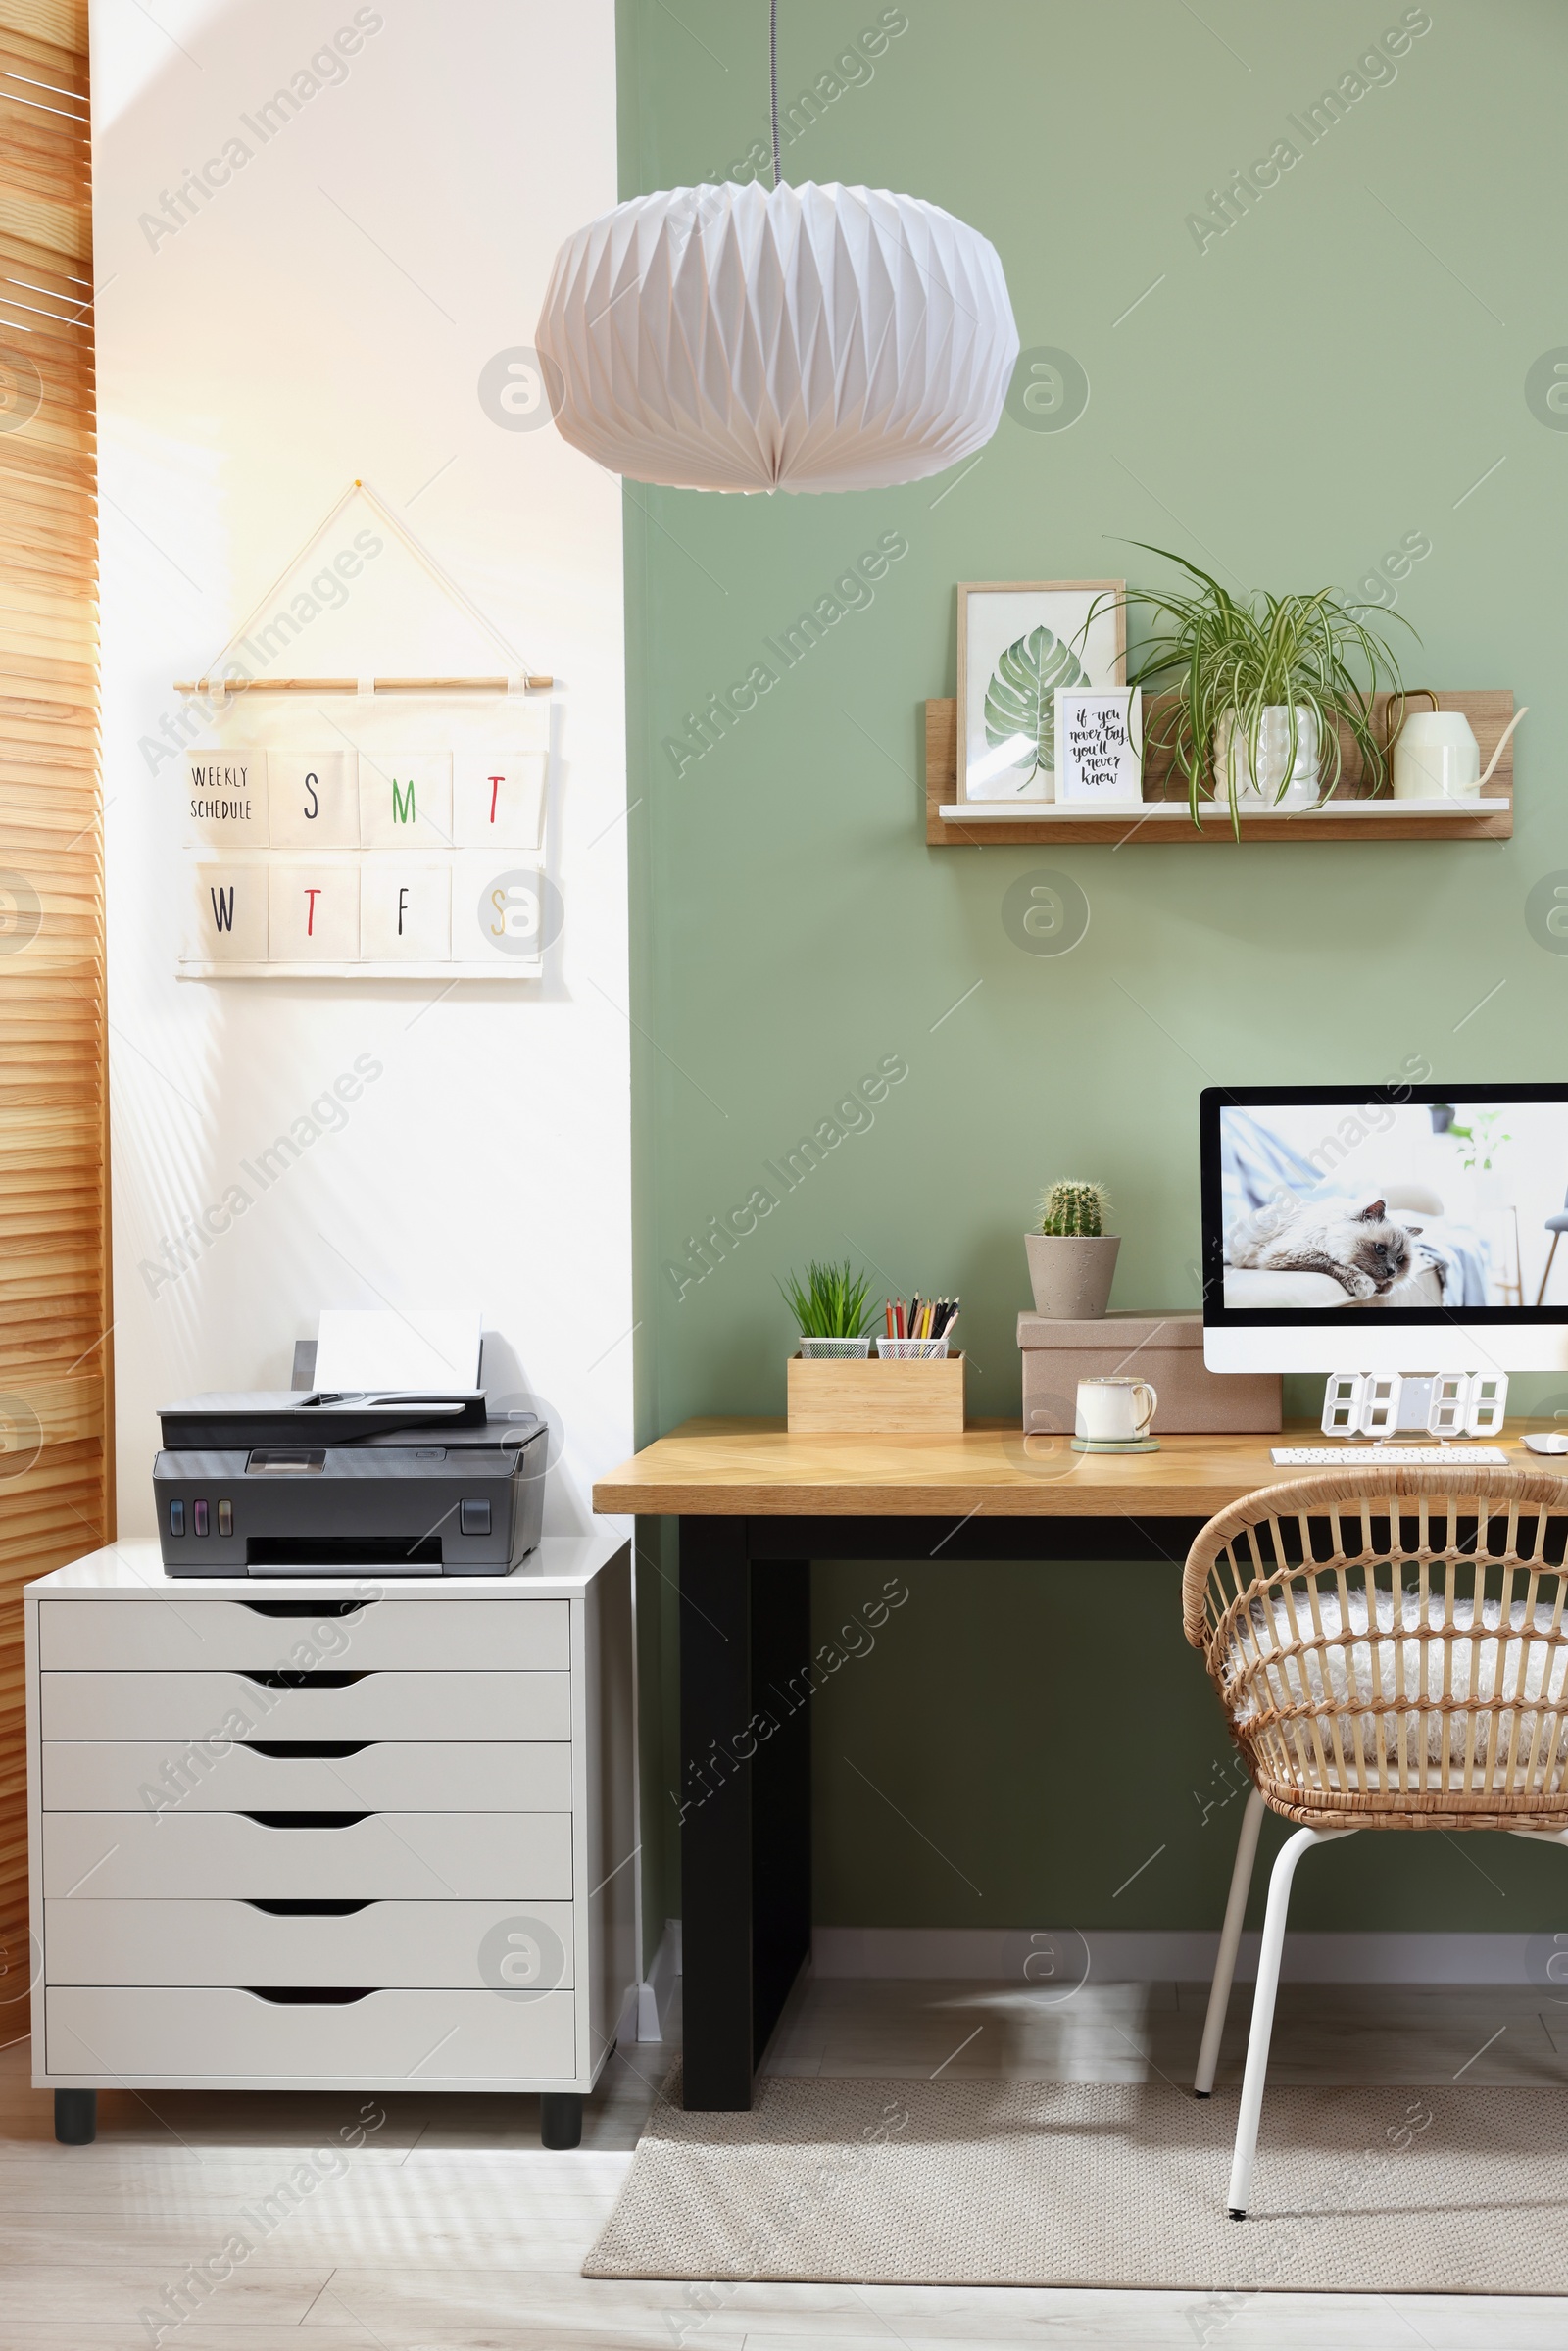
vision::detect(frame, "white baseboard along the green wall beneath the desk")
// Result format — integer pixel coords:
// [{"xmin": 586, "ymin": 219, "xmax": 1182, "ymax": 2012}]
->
[{"xmin": 811, "ymin": 1926, "xmax": 1546, "ymax": 1984}]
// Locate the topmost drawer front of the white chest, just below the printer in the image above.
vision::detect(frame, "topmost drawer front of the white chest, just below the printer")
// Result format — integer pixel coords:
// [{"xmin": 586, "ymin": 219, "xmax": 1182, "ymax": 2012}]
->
[{"xmin": 37, "ymin": 1594, "xmax": 571, "ymax": 1674}]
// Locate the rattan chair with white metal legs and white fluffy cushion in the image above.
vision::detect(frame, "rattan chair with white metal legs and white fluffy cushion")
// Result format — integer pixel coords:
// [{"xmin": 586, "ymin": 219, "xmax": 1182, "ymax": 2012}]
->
[{"xmin": 1183, "ymin": 1465, "xmax": 1568, "ymax": 2220}]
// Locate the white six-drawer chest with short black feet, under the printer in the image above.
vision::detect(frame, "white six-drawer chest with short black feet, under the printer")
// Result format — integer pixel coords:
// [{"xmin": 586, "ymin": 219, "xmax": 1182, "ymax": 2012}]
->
[{"xmin": 25, "ymin": 1533, "xmax": 637, "ymax": 2146}]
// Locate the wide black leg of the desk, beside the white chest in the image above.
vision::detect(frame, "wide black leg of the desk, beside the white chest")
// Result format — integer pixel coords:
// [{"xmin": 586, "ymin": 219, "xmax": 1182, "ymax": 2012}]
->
[{"xmin": 679, "ymin": 1519, "xmax": 811, "ymax": 2114}]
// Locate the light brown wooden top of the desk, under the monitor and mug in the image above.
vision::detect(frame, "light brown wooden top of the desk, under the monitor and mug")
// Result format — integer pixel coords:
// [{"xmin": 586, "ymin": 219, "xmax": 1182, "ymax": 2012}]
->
[{"xmin": 592, "ymin": 1420, "xmax": 1544, "ymax": 1519}]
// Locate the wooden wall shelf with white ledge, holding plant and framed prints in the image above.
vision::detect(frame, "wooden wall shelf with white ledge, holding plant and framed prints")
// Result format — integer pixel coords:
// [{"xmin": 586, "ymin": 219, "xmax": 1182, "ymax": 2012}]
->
[{"xmin": 926, "ymin": 689, "xmax": 1514, "ymax": 849}]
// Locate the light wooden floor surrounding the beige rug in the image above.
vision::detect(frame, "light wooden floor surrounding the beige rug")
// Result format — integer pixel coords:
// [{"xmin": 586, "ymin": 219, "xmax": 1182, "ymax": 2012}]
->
[{"xmin": 0, "ymin": 1980, "xmax": 1568, "ymax": 2351}]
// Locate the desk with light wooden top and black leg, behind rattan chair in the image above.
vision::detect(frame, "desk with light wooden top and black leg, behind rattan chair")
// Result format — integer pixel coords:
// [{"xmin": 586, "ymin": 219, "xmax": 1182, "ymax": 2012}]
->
[{"xmin": 592, "ymin": 1420, "xmax": 1531, "ymax": 2111}]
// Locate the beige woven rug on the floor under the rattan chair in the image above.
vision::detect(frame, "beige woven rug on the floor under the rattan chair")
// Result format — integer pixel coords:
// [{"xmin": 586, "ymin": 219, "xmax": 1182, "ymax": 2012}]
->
[{"xmin": 583, "ymin": 2076, "xmax": 1568, "ymax": 2321}]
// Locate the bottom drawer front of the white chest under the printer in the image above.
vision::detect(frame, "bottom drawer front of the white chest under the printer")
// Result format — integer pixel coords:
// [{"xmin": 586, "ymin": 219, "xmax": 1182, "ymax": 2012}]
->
[{"xmin": 45, "ymin": 1984, "xmax": 576, "ymax": 2090}]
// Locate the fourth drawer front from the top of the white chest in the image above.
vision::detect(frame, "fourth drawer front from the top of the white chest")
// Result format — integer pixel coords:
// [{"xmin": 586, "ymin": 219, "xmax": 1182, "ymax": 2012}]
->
[{"xmin": 42, "ymin": 1813, "xmax": 571, "ymax": 1902}]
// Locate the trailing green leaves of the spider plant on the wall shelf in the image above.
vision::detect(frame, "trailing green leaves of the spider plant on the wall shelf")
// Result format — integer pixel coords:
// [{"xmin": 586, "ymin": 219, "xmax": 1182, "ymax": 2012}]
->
[{"xmin": 1081, "ymin": 538, "xmax": 1420, "ymax": 837}]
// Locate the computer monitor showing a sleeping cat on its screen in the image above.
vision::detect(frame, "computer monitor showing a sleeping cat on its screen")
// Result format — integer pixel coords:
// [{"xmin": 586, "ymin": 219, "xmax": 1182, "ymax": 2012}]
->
[{"xmin": 1199, "ymin": 1084, "xmax": 1568, "ymax": 1373}]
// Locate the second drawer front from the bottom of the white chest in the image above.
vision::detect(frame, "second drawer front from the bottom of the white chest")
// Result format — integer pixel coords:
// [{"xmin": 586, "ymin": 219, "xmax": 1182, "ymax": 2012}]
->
[{"xmin": 45, "ymin": 1895, "xmax": 571, "ymax": 1991}]
